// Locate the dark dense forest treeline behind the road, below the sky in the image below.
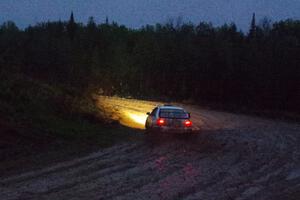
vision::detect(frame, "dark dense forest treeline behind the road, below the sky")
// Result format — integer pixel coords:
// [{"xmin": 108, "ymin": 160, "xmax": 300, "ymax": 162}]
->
[{"xmin": 0, "ymin": 15, "xmax": 300, "ymax": 113}]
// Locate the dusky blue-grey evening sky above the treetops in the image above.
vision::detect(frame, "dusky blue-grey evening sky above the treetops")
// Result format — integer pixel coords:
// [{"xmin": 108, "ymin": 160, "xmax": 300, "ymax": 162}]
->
[{"xmin": 0, "ymin": 0, "xmax": 300, "ymax": 30}]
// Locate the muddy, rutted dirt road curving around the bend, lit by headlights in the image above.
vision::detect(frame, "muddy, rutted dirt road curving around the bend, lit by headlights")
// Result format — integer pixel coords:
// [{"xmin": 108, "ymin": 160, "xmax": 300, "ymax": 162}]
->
[{"xmin": 0, "ymin": 97, "xmax": 300, "ymax": 200}]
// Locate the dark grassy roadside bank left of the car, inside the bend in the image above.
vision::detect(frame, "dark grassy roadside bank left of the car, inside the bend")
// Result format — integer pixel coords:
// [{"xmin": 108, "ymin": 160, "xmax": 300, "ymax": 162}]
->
[{"xmin": 0, "ymin": 70, "xmax": 140, "ymax": 177}]
